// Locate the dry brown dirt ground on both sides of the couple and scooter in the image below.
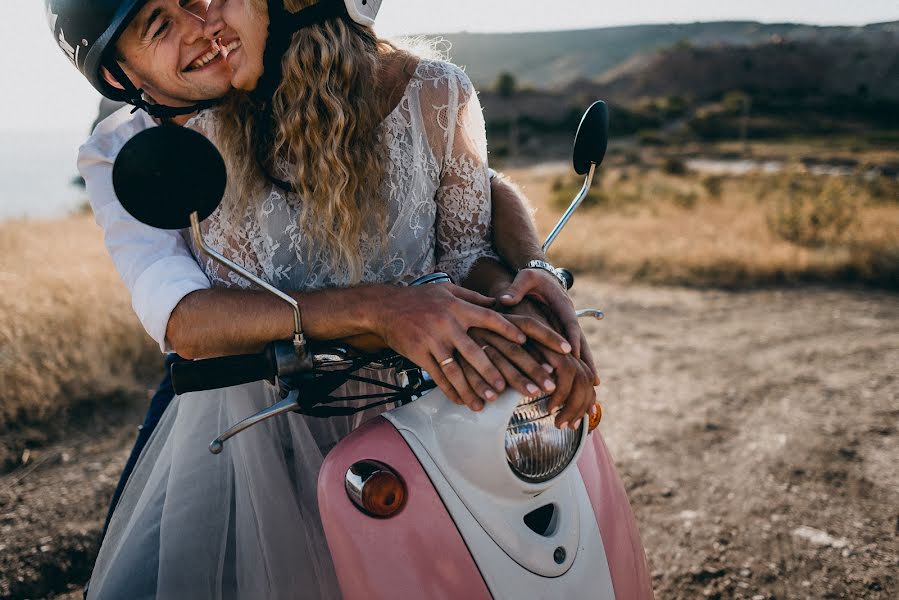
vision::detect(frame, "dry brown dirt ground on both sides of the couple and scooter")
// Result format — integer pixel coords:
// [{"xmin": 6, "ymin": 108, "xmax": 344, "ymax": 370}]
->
[{"xmin": 0, "ymin": 278, "xmax": 899, "ymax": 600}]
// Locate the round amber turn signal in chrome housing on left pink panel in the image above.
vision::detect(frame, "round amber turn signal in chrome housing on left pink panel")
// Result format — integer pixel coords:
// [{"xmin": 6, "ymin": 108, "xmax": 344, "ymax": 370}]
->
[{"xmin": 345, "ymin": 460, "xmax": 406, "ymax": 519}]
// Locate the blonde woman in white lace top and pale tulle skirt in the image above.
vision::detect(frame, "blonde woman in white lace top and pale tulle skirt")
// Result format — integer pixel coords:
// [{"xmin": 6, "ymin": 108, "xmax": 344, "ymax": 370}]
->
[{"xmin": 89, "ymin": 0, "xmax": 586, "ymax": 598}]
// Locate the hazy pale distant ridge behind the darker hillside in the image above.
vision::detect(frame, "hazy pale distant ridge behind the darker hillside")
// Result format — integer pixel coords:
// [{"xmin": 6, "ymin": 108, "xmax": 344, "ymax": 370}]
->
[{"xmin": 436, "ymin": 21, "xmax": 899, "ymax": 89}]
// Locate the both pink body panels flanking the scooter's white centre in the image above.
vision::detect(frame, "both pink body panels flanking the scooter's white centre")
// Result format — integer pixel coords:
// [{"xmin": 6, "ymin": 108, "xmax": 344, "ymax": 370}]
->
[{"xmin": 318, "ymin": 417, "xmax": 653, "ymax": 600}]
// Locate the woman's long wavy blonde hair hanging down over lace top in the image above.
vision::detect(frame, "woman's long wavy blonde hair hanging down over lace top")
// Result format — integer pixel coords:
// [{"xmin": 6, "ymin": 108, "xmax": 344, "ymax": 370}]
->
[{"xmin": 216, "ymin": 0, "xmax": 396, "ymax": 283}]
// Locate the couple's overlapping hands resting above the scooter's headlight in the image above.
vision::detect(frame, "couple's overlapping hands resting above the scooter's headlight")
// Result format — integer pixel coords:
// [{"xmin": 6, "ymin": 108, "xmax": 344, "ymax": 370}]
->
[{"xmin": 378, "ymin": 269, "xmax": 599, "ymax": 428}]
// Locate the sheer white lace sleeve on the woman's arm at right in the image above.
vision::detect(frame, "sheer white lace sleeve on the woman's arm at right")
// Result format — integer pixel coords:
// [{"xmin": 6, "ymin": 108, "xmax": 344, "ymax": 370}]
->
[{"xmin": 423, "ymin": 63, "xmax": 497, "ymax": 283}]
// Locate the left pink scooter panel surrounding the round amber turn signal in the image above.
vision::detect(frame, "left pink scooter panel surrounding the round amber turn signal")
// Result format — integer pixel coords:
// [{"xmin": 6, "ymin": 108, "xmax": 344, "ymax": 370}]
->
[{"xmin": 318, "ymin": 417, "xmax": 491, "ymax": 600}]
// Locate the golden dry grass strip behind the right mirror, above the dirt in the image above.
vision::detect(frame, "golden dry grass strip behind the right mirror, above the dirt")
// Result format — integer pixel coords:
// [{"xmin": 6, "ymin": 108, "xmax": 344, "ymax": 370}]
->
[{"xmin": 508, "ymin": 165, "xmax": 899, "ymax": 289}]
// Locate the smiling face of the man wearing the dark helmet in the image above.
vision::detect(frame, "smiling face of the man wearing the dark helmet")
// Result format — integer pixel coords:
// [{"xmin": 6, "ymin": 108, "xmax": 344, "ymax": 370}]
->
[{"xmin": 108, "ymin": 0, "xmax": 231, "ymax": 106}]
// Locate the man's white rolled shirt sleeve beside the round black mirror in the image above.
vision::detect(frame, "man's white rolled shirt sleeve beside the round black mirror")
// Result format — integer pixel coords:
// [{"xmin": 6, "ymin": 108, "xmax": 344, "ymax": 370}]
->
[{"xmin": 78, "ymin": 113, "xmax": 210, "ymax": 352}]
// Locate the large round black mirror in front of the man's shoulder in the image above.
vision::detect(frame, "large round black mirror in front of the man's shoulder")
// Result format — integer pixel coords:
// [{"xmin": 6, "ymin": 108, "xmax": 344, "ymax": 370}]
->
[{"xmin": 112, "ymin": 125, "xmax": 228, "ymax": 229}]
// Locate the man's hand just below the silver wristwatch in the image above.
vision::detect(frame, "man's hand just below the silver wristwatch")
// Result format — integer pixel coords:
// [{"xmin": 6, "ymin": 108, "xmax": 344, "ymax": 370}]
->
[{"xmin": 497, "ymin": 269, "xmax": 599, "ymax": 385}]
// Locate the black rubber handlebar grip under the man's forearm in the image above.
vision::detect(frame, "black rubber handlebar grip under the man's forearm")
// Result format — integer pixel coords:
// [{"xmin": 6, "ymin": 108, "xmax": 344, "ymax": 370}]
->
[{"xmin": 172, "ymin": 352, "xmax": 277, "ymax": 395}]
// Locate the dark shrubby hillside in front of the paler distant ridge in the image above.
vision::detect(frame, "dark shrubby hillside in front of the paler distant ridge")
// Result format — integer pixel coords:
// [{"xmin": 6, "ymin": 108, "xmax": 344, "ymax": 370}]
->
[{"xmin": 471, "ymin": 23, "xmax": 899, "ymax": 153}]
